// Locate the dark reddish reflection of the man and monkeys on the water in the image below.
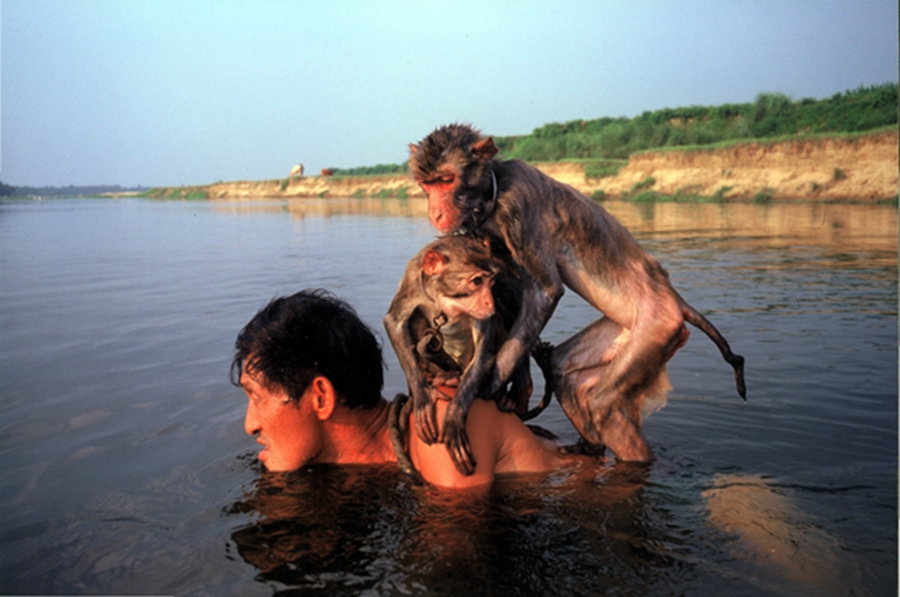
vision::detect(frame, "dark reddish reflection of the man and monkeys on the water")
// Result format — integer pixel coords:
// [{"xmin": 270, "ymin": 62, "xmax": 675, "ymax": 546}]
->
[{"xmin": 231, "ymin": 466, "xmax": 673, "ymax": 595}]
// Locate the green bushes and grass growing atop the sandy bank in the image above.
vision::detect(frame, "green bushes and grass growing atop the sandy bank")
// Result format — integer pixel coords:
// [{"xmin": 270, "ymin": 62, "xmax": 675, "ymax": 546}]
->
[{"xmin": 333, "ymin": 83, "xmax": 898, "ymax": 176}]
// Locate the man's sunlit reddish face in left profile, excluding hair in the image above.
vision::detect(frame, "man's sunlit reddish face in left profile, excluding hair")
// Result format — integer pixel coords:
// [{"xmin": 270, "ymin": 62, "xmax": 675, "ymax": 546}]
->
[{"xmin": 241, "ymin": 369, "xmax": 324, "ymax": 472}]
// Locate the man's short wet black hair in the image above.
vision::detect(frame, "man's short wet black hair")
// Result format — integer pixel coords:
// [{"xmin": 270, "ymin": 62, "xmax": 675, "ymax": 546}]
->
[{"xmin": 231, "ymin": 289, "xmax": 384, "ymax": 408}]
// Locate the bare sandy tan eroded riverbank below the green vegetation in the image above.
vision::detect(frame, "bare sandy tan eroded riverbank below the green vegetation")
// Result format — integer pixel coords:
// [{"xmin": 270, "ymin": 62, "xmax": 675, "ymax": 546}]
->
[{"xmin": 145, "ymin": 128, "xmax": 900, "ymax": 202}]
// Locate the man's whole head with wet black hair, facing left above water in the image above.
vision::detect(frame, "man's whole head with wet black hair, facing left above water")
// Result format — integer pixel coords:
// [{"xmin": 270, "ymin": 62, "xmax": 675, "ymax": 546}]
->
[{"xmin": 231, "ymin": 291, "xmax": 384, "ymax": 471}]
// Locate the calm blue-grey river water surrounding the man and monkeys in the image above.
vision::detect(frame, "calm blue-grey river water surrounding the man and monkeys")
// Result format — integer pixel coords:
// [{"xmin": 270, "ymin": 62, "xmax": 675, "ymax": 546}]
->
[{"xmin": 0, "ymin": 199, "xmax": 898, "ymax": 595}]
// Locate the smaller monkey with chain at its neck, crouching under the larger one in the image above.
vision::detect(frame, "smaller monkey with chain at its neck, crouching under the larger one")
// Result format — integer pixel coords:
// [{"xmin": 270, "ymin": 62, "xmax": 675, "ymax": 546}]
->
[{"xmin": 384, "ymin": 236, "xmax": 532, "ymax": 475}]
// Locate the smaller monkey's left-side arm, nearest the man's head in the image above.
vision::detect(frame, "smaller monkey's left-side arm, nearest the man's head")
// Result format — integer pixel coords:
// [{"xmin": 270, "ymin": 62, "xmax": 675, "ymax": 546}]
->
[{"xmin": 384, "ymin": 276, "xmax": 439, "ymax": 444}]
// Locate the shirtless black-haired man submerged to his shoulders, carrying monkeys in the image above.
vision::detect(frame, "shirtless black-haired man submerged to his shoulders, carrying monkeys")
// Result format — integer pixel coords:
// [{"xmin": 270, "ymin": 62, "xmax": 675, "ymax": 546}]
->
[{"xmin": 231, "ymin": 290, "xmax": 575, "ymax": 487}]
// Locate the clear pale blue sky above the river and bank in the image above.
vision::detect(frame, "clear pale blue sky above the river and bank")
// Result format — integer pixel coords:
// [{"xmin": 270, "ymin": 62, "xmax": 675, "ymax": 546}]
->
[{"xmin": 0, "ymin": 0, "xmax": 898, "ymax": 187}]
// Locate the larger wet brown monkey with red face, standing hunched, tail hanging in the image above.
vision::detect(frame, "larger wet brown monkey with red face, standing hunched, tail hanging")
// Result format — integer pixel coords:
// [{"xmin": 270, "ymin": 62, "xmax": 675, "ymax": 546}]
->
[{"xmin": 409, "ymin": 124, "xmax": 746, "ymax": 460}]
